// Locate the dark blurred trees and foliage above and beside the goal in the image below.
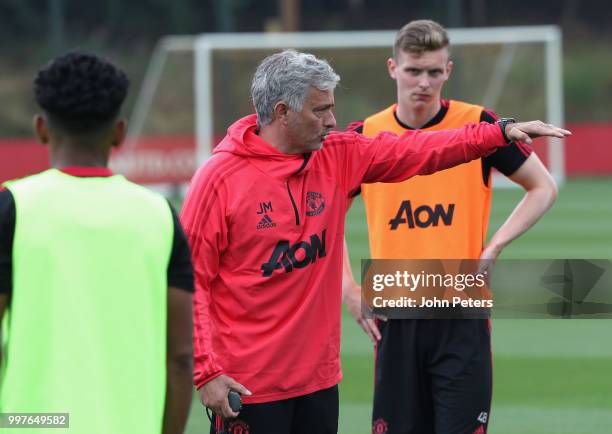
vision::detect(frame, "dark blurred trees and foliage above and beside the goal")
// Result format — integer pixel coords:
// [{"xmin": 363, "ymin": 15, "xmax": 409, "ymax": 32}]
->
[{"xmin": 0, "ymin": 0, "xmax": 612, "ymax": 137}]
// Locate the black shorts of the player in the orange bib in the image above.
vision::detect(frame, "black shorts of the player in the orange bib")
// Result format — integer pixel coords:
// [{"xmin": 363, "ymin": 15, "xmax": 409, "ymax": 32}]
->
[{"xmin": 372, "ymin": 319, "xmax": 493, "ymax": 434}]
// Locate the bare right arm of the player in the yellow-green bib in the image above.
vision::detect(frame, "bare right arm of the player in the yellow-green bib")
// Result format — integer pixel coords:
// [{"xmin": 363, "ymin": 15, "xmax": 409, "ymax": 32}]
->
[{"xmin": 163, "ymin": 287, "xmax": 193, "ymax": 434}]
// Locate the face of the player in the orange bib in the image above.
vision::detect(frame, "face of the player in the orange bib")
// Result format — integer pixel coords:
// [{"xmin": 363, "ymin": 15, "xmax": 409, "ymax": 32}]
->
[{"xmin": 387, "ymin": 48, "xmax": 453, "ymax": 110}]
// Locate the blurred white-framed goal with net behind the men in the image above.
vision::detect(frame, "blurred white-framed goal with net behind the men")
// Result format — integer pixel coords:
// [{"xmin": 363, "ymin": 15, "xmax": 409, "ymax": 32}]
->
[{"xmin": 119, "ymin": 26, "xmax": 564, "ymax": 185}]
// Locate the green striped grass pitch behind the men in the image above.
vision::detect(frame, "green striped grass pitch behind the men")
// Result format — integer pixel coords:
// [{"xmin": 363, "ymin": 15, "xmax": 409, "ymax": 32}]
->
[{"xmin": 187, "ymin": 178, "xmax": 612, "ymax": 434}]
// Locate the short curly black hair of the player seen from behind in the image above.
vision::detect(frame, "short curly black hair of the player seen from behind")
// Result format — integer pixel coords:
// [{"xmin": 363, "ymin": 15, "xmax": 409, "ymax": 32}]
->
[{"xmin": 34, "ymin": 51, "xmax": 130, "ymax": 132}]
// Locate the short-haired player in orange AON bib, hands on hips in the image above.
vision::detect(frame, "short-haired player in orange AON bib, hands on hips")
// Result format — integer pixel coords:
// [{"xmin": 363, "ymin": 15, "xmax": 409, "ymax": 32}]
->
[{"xmin": 343, "ymin": 20, "xmax": 557, "ymax": 434}]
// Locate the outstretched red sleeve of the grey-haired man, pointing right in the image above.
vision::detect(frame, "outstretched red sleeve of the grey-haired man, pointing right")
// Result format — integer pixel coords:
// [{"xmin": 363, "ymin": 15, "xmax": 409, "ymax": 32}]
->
[{"xmin": 330, "ymin": 122, "xmax": 507, "ymax": 195}]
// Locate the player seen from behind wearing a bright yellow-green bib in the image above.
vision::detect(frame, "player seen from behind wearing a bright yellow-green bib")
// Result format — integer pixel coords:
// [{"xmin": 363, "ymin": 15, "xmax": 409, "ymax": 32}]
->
[{"xmin": 0, "ymin": 52, "xmax": 194, "ymax": 434}]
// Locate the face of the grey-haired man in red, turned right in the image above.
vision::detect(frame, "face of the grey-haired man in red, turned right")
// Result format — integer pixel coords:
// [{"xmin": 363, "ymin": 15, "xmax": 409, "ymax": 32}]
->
[{"xmin": 287, "ymin": 87, "xmax": 336, "ymax": 153}]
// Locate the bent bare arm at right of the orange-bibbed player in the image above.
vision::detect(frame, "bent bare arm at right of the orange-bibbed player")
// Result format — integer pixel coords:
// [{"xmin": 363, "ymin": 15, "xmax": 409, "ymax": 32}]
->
[{"xmin": 481, "ymin": 153, "xmax": 557, "ymax": 260}]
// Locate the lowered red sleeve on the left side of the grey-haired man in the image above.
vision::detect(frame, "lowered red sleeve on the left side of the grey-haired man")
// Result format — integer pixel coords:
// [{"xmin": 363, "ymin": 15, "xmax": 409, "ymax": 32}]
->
[{"xmin": 181, "ymin": 161, "xmax": 227, "ymax": 389}]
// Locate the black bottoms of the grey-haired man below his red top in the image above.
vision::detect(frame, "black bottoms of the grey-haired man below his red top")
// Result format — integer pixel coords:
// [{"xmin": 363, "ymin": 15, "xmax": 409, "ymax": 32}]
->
[{"xmin": 210, "ymin": 386, "xmax": 338, "ymax": 434}]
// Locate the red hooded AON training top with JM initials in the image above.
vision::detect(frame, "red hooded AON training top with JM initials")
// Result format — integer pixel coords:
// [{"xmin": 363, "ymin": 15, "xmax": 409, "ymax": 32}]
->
[{"xmin": 181, "ymin": 115, "xmax": 505, "ymax": 403}]
